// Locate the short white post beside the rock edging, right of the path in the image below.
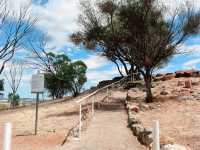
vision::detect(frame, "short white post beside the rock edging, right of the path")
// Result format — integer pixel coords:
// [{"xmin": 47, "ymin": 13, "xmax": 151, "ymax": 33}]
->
[{"xmin": 153, "ymin": 121, "xmax": 160, "ymax": 150}]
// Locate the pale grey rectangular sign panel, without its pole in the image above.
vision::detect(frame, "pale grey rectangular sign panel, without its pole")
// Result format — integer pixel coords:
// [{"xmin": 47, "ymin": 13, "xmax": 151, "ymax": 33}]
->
[{"xmin": 31, "ymin": 74, "xmax": 44, "ymax": 93}]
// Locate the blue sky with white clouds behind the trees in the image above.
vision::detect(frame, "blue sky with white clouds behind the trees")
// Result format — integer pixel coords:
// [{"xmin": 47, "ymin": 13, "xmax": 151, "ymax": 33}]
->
[{"xmin": 0, "ymin": 0, "xmax": 200, "ymax": 98}]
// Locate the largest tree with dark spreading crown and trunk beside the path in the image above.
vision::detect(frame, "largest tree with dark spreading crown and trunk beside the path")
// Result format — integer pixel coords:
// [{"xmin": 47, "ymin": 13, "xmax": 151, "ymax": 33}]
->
[{"xmin": 71, "ymin": 0, "xmax": 200, "ymax": 102}]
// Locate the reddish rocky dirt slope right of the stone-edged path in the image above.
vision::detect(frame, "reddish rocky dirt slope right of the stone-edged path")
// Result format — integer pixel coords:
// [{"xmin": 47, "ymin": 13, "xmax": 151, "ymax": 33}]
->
[{"xmin": 129, "ymin": 78, "xmax": 200, "ymax": 150}]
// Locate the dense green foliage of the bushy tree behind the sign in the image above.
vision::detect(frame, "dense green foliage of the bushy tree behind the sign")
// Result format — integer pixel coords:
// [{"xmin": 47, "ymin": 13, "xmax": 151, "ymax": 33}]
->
[{"xmin": 45, "ymin": 53, "xmax": 87, "ymax": 99}]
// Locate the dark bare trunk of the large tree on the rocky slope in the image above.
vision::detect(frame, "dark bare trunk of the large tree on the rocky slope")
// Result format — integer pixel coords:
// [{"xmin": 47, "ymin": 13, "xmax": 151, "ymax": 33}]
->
[{"xmin": 144, "ymin": 71, "xmax": 153, "ymax": 103}]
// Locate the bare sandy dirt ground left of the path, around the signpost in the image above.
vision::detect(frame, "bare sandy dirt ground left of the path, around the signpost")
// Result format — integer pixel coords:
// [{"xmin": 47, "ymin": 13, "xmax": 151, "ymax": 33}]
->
[{"xmin": 0, "ymin": 89, "xmax": 108, "ymax": 150}]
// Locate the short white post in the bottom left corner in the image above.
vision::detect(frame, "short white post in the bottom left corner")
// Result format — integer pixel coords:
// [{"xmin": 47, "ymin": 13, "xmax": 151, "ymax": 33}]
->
[{"xmin": 3, "ymin": 123, "xmax": 12, "ymax": 150}]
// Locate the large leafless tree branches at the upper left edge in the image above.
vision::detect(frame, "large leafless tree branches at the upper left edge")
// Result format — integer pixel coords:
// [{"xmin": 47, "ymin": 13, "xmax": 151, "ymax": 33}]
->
[{"xmin": 0, "ymin": 0, "xmax": 36, "ymax": 74}]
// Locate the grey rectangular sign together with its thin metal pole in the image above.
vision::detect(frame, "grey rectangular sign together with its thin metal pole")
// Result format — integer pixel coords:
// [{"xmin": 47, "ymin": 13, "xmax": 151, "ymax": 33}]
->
[{"xmin": 31, "ymin": 71, "xmax": 44, "ymax": 135}]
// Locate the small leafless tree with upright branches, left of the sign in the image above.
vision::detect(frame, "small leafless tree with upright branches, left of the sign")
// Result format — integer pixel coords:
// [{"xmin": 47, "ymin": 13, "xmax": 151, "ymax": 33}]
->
[{"xmin": 4, "ymin": 60, "xmax": 24, "ymax": 107}]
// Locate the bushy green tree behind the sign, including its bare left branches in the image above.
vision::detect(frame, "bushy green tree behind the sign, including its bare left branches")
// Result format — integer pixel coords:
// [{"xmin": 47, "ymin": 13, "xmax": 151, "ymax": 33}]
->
[{"xmin": 29, "ymin": 39, "xmax": 87, "ymax": 98}]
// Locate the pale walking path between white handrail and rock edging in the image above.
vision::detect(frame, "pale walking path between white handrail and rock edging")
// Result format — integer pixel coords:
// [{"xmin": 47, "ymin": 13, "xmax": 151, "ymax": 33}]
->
[{"xmin": 62, "ymin": 90, "xmax": 145, "ymax": 150}]
